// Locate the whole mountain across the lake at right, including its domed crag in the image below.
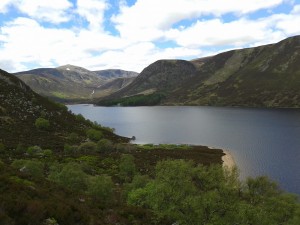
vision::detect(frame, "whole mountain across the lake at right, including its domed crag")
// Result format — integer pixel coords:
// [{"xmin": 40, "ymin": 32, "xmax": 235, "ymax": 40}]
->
[{"xmin": 98, "ymin": 36, "xmax": 300, "ymax": 107}]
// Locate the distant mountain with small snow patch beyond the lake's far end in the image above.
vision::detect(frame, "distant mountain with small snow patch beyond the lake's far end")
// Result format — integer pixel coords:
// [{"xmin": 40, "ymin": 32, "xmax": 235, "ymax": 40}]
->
[{"xmin": 14, "ymin": 65, "xmax": 137, "ymax": 102}]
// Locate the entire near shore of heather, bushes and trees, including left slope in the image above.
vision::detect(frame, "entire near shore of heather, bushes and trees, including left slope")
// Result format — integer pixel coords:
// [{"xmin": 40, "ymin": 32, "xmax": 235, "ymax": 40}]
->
[{"xmin": 0, "ymin": 68, "xmax": 300, "ymax": 225}]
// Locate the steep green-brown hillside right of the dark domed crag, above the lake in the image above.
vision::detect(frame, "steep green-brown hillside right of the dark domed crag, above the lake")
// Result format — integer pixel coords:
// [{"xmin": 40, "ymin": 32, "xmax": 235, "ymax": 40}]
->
[{"xmin": 168, "ymin": 36, "xmax": 300, "ymax": 107}]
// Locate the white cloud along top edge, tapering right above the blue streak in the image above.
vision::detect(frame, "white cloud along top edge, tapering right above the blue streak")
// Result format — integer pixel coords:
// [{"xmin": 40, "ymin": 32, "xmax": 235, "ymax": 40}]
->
[{"xmin": 112, "ymin": 0, "xmax": 283, "ymax": 40}]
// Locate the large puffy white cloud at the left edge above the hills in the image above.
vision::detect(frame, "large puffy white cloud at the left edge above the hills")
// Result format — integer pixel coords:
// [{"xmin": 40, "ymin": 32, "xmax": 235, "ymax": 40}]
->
[{"xmin": 0, "ymin": 18, "xmax": 77, "ymax": 69}]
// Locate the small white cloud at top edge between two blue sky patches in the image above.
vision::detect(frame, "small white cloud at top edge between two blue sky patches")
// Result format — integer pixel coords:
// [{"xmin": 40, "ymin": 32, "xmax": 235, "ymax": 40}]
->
[{"xmin": 77, "ymin": 0, "xmax": 109, "ymax": 29}]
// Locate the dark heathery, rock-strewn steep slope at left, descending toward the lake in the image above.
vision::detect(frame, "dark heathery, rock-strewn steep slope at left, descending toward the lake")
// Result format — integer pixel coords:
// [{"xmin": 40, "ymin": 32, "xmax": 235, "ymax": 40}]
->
[{"xmin": 0, "ymin": 70, "xmax": 124, "ymax": 150}]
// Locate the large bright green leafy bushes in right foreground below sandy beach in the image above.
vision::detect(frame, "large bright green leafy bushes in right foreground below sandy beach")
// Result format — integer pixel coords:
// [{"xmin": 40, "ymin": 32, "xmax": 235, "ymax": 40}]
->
[{"xmin": 127, "ymin": 160, "xmax": 300, "ymax": 225}]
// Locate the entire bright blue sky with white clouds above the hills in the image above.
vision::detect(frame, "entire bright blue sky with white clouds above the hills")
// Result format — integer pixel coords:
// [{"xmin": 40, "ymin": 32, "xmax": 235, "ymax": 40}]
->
[{"xmin": 0, "ymin": 0, "xmax": 300, "ymax": 72}]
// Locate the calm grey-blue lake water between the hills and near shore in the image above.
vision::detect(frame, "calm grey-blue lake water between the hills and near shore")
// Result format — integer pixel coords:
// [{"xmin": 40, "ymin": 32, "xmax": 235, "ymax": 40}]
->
[{"xmin": 68, "ymin": 105, "xmax": 300, "ymax": 194}]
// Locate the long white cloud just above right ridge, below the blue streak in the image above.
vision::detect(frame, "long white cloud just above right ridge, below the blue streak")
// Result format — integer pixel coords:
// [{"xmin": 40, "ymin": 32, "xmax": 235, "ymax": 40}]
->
[{"xmin": 166, "ymin": 19, "xmax": 278, "ymax": 48}]
